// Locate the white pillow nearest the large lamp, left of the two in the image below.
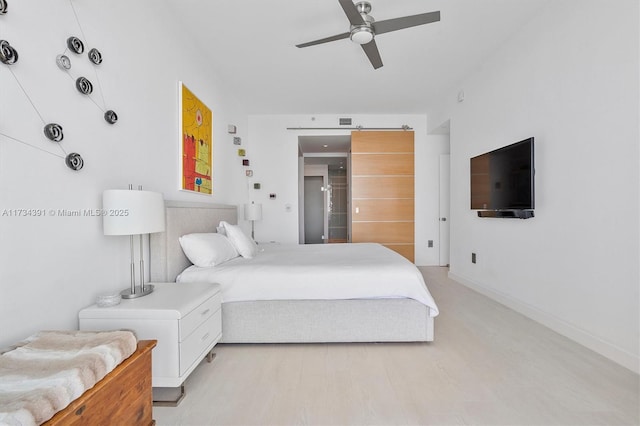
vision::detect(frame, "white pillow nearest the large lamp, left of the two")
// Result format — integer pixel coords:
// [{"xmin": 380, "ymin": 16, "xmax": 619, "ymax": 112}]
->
[{"xmin": 179, "ymin": 233, "xmax": 238, "ymax": 268}]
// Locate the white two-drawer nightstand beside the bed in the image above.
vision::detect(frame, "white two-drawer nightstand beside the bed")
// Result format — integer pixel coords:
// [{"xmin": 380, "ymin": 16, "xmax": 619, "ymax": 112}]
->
[{"xmin": 78, "ymin": 283, "xmax": 222, "ymax": 404}]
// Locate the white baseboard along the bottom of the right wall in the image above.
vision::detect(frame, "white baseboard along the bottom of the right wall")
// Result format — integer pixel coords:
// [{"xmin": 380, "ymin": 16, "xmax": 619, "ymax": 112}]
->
[{"xmin": 449, "ymin": 271, "xmax": 640, "ymax": 374}]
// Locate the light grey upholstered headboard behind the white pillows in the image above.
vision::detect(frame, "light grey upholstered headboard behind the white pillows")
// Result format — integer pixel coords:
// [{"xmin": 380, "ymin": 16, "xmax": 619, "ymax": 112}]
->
[{"xmin": 149, "ymin": 201, "xmax": 238, "ymax": 282}]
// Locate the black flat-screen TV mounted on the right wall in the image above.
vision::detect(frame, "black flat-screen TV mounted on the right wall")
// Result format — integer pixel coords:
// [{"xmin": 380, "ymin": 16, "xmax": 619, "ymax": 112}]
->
[{"xmin": 471, "ymin": 138, "xmax": 535, "ymax": 219}]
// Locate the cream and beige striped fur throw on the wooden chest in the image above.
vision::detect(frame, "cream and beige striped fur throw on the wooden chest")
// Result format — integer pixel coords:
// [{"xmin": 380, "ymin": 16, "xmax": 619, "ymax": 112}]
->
[{"xmin": 0, "ymin": 331, "xmax": 137, "ymax": 425}]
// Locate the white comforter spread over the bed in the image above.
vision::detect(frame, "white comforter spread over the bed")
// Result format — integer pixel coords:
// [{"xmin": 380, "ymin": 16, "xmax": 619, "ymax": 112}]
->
[{"xmin": 176, "ymin": 243, "xmax": 438, "ymax": 316}]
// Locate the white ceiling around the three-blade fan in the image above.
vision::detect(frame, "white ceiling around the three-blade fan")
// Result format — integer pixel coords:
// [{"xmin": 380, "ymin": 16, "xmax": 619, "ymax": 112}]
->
[{"xmin": 163, "ymin": 0, "xmax": 550, "ymax": 114}]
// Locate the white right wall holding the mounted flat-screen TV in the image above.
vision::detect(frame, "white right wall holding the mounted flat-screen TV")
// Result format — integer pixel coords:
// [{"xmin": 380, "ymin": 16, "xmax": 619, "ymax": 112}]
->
[{"xmin": 429, "ymin": 0, "xmax": 640, "ymax": 371}]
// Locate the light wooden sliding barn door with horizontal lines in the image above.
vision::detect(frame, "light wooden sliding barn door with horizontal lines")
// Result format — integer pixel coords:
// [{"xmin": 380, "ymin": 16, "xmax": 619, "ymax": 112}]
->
[{"xmin": 351, "ymin": 131, "xmax": 415, "ymax": 262}]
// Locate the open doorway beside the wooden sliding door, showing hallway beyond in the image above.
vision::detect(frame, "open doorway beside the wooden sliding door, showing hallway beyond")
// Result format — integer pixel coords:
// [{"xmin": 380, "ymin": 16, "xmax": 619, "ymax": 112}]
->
[{"xmin": 298, "ymin": 135, "xmax": 351, "ymax": 244}]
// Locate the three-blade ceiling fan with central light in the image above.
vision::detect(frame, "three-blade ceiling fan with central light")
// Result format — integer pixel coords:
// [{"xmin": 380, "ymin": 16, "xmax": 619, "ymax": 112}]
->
[{"xmin": 296, "ymin": 0, "xmax": 440, "ymax": 69}]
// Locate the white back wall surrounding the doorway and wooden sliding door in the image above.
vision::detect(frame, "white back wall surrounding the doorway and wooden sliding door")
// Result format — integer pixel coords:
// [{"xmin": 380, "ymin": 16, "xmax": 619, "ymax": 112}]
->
[{"xmin": 242, "ymin": 114, "xmax": 448, "ymax": 265}]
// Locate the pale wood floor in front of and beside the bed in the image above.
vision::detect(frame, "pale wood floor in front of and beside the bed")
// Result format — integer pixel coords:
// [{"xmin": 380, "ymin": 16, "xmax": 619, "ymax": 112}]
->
[{"xmin": 154, "ymin": 267, "xmax": 640, "ymax": 425}]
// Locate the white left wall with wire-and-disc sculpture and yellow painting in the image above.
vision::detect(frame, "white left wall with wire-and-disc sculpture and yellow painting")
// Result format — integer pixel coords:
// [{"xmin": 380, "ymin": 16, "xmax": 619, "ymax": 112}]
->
[{"xmin": 0, "ymin": 0, "xmax": 247, "ymax": 346}]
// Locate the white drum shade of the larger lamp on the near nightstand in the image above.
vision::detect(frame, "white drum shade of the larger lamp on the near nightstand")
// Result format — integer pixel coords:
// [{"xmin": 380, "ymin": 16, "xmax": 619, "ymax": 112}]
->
[{"xmin": 102, "ymin": 189, "xmax": 165, "ymax": 235}]
